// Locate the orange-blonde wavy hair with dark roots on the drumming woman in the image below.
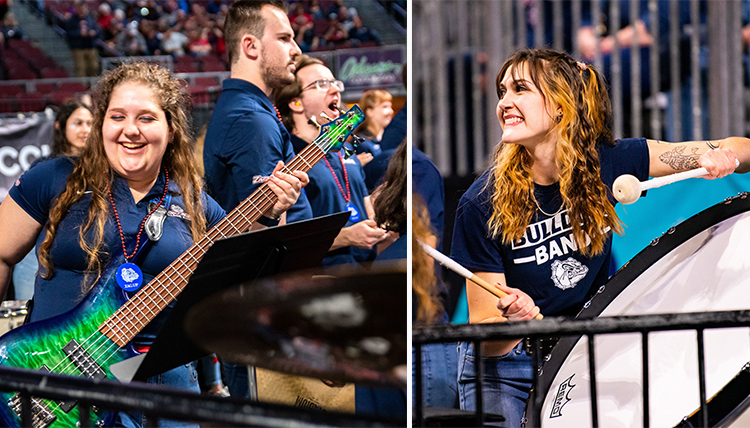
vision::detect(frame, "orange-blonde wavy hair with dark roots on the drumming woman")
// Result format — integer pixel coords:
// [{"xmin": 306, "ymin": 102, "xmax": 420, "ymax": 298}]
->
[{"xmin": 487, "ymin": 49, "xmax": 622, "ymax": 256}]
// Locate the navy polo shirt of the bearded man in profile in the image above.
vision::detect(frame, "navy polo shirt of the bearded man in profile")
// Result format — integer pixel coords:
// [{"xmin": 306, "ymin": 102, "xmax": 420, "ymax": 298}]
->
[{"xmin": 203, "ymin": 79, "xmax": 312, "ymax": 223}]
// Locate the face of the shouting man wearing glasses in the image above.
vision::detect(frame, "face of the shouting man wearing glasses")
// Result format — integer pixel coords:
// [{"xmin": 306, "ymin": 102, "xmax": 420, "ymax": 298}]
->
[{"xmin": 297, "ymin": 64, "xmax": 341, "ymax": 125}]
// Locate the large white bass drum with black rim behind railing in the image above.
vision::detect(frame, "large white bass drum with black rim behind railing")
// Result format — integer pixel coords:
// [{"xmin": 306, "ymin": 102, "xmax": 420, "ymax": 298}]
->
[{"xmin": 527, "ymin": 193, "xmax": 750, "ymax": 428}]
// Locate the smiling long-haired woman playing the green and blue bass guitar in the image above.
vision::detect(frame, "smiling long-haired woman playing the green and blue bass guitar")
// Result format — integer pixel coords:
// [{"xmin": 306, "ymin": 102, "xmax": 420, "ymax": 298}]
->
[{"xmin": 0, "ymin": 63, "xmax": 307, "ymax": 427}]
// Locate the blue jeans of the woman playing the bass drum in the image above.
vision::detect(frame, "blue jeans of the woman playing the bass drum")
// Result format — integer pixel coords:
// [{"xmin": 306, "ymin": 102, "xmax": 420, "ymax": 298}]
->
[{"xmin": 458, "ymin": 342, "xmax": 534, "ymax": 427}]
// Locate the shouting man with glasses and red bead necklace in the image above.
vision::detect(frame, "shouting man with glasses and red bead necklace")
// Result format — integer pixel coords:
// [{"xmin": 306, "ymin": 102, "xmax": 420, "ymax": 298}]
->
[{"xmin": 274, "ymin": 55, "xmax": 387, "ymax": 266}]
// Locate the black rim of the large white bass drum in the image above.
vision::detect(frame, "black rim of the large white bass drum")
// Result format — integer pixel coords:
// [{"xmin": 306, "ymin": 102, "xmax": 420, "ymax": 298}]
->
[{"xmin": 526, "ymin": 192, "xmax": 750, "ymax": 427}]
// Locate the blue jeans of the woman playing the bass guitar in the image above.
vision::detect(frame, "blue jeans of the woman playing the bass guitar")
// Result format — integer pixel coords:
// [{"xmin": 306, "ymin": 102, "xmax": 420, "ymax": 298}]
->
[{"xmin": 115, "ymin": 361, "xmax": 201, "ymax": 428}]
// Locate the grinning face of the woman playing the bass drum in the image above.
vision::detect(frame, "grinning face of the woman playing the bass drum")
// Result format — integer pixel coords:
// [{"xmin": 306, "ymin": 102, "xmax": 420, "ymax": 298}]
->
[{"xmin": 497, "ymin": 64, "xmax": 555, "ymax": 147}]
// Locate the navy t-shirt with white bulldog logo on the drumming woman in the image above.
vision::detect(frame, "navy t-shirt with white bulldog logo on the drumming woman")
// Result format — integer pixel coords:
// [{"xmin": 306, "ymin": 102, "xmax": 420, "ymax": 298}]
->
[{"xmin": 451, "ymin": 139, "xmax": 649, "ymax": 315}]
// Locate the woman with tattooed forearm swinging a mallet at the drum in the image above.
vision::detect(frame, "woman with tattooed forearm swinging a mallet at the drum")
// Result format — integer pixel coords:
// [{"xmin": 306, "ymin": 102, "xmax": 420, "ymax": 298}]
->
[{"xmin": 452, "ymin": 49, "xmax": 750, "ymax": 427}]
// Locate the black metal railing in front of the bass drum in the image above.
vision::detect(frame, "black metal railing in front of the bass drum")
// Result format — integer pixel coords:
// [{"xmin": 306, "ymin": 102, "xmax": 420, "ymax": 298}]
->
[{"xmin": 412, "ymin": 310, "xmax": 750, "ymax": 427}]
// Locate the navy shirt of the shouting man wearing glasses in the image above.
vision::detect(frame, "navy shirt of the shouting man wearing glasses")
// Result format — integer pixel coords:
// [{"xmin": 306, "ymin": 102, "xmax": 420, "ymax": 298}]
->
[{"xmin": 291, "ymin": 135, "xmax": 376, "ymax": 266}]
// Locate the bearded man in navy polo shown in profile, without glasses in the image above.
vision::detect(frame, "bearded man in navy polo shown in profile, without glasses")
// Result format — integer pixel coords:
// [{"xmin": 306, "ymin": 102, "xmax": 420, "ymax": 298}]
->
[{"xmin": 203, "ymin": 0, "xmax": 312, "ymax": 226}]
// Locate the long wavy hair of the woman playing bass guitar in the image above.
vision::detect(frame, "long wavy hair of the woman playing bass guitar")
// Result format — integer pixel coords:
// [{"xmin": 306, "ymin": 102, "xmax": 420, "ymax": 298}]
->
[{"xmin": 39, "ymin": 63, "xmax": 206, "ymax": 292}]
